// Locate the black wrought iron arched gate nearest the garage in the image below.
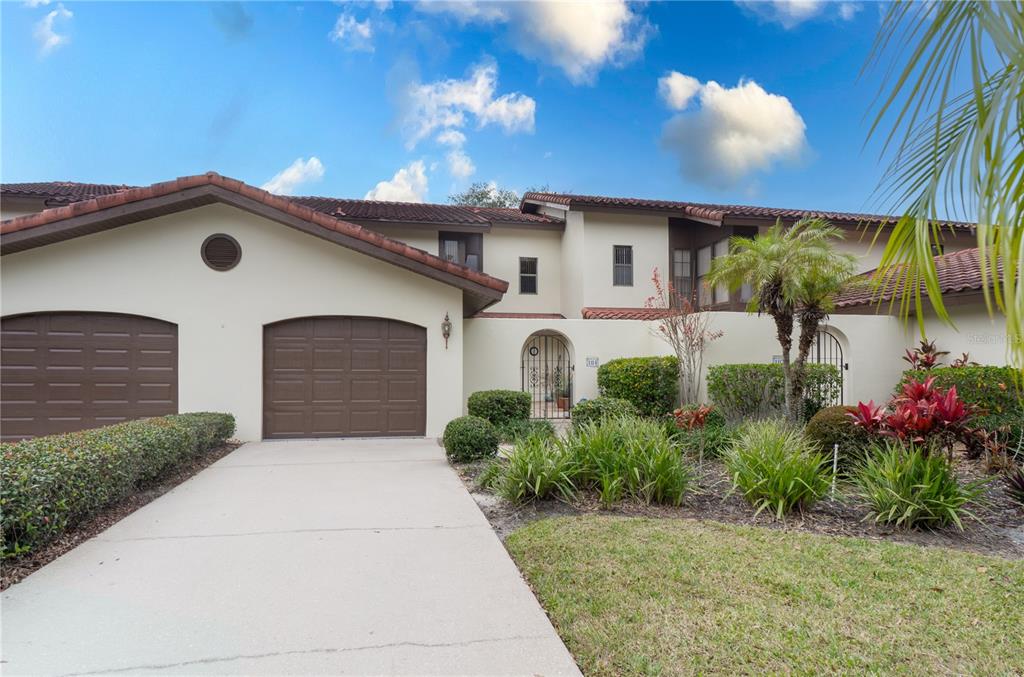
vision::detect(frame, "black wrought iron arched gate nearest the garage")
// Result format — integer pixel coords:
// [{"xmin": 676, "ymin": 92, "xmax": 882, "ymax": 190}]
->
[{"xmin": 522, "ymin": 334, "xmax": 573, "ymax": 419}]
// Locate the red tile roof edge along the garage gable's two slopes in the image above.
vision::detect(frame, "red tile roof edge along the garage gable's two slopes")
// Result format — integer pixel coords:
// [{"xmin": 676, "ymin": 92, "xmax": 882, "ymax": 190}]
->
[{"xmin": 0, "ymin": 172, "xmax": 509, "ymax": 293}]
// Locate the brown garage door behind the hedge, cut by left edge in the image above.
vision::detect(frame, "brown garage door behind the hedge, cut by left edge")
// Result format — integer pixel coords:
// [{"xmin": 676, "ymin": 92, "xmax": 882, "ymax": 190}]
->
[{"xmin": 0, "ymin": 312, "xmax": 178, "ymax": 440}]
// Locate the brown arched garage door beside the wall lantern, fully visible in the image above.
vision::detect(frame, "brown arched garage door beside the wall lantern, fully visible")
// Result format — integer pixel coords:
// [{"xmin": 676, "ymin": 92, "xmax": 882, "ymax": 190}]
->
[{"xmin": 263, "ymin": 318, "xmax": 427, "ymax": 438}]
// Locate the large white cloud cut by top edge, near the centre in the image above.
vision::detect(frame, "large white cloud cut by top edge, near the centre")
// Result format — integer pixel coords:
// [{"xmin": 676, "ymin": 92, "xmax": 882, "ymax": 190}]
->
[{"xmin": 418, "ymin": 0, "xmax": 653, "ymax": 84}]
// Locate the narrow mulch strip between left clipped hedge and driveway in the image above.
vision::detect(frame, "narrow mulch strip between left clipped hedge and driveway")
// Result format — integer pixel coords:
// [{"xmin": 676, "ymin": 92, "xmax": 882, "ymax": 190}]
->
[{"xmin": 0, "ymin": 441, "xmax": 242, "ymax": 590}]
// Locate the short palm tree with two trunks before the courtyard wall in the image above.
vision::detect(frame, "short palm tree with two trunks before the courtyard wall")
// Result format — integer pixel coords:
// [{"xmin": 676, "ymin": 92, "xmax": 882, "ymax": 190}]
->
[{"xmin": 708, "ymin": 218, "xmax": 855, "ymax": 421}]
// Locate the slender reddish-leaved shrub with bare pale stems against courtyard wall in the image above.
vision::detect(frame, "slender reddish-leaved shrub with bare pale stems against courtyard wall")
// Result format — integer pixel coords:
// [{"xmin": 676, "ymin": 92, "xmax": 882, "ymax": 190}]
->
[{"xmin": 644, "ymin": 268, "xmax": 722, "ymax": 405}]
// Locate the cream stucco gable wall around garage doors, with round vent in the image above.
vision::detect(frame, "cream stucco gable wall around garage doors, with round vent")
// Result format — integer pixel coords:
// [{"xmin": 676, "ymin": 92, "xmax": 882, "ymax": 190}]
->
[{"xmin": 0, "ymin": 205, "xmax": 464, "ymax": 439}]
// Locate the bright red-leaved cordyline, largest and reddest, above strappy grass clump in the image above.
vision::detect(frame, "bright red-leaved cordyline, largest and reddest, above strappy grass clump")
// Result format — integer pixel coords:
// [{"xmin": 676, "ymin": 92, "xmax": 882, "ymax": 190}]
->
[{"xmin": 850, "ymin": 376, "xmax": 975, "ymax": 448}]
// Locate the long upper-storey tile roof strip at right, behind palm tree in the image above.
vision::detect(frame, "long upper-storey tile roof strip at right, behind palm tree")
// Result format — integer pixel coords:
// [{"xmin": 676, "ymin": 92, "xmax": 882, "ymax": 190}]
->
[{"xmin": 522, "ymin": 193, "xmax": 974, "ymax": 228}]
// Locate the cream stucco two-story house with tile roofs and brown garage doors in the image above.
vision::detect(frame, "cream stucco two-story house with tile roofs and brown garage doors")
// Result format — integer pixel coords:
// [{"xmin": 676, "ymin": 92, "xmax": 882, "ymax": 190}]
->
[{"xmin": 0, "ymin": 173, "xmax": 1006, "ymax": 439}]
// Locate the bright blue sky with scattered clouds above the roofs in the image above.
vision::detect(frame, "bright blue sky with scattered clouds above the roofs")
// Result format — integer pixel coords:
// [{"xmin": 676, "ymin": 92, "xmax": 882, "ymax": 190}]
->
[{"xmin": 0, "ymin": 0, "xmax": 901, "ymax": 211}]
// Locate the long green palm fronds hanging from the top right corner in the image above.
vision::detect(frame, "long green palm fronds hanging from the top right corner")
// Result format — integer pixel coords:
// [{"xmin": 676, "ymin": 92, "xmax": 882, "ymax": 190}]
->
[{"xmin": 870, "ymin": 0, "xmax": 1024, "ymax": 370}]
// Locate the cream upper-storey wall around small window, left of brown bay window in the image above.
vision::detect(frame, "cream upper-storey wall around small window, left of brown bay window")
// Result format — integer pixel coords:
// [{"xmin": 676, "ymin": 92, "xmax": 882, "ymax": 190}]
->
[{"xmin": 581, "ymin": 212, "xmax": 669, "ymax": 309}]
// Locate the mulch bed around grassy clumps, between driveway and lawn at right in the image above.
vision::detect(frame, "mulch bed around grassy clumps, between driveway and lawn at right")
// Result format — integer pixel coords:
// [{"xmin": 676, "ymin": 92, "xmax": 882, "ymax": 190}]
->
[{"xmin": 456, "ymin": 460, "xmax": 1024, "ymax": 559}]
